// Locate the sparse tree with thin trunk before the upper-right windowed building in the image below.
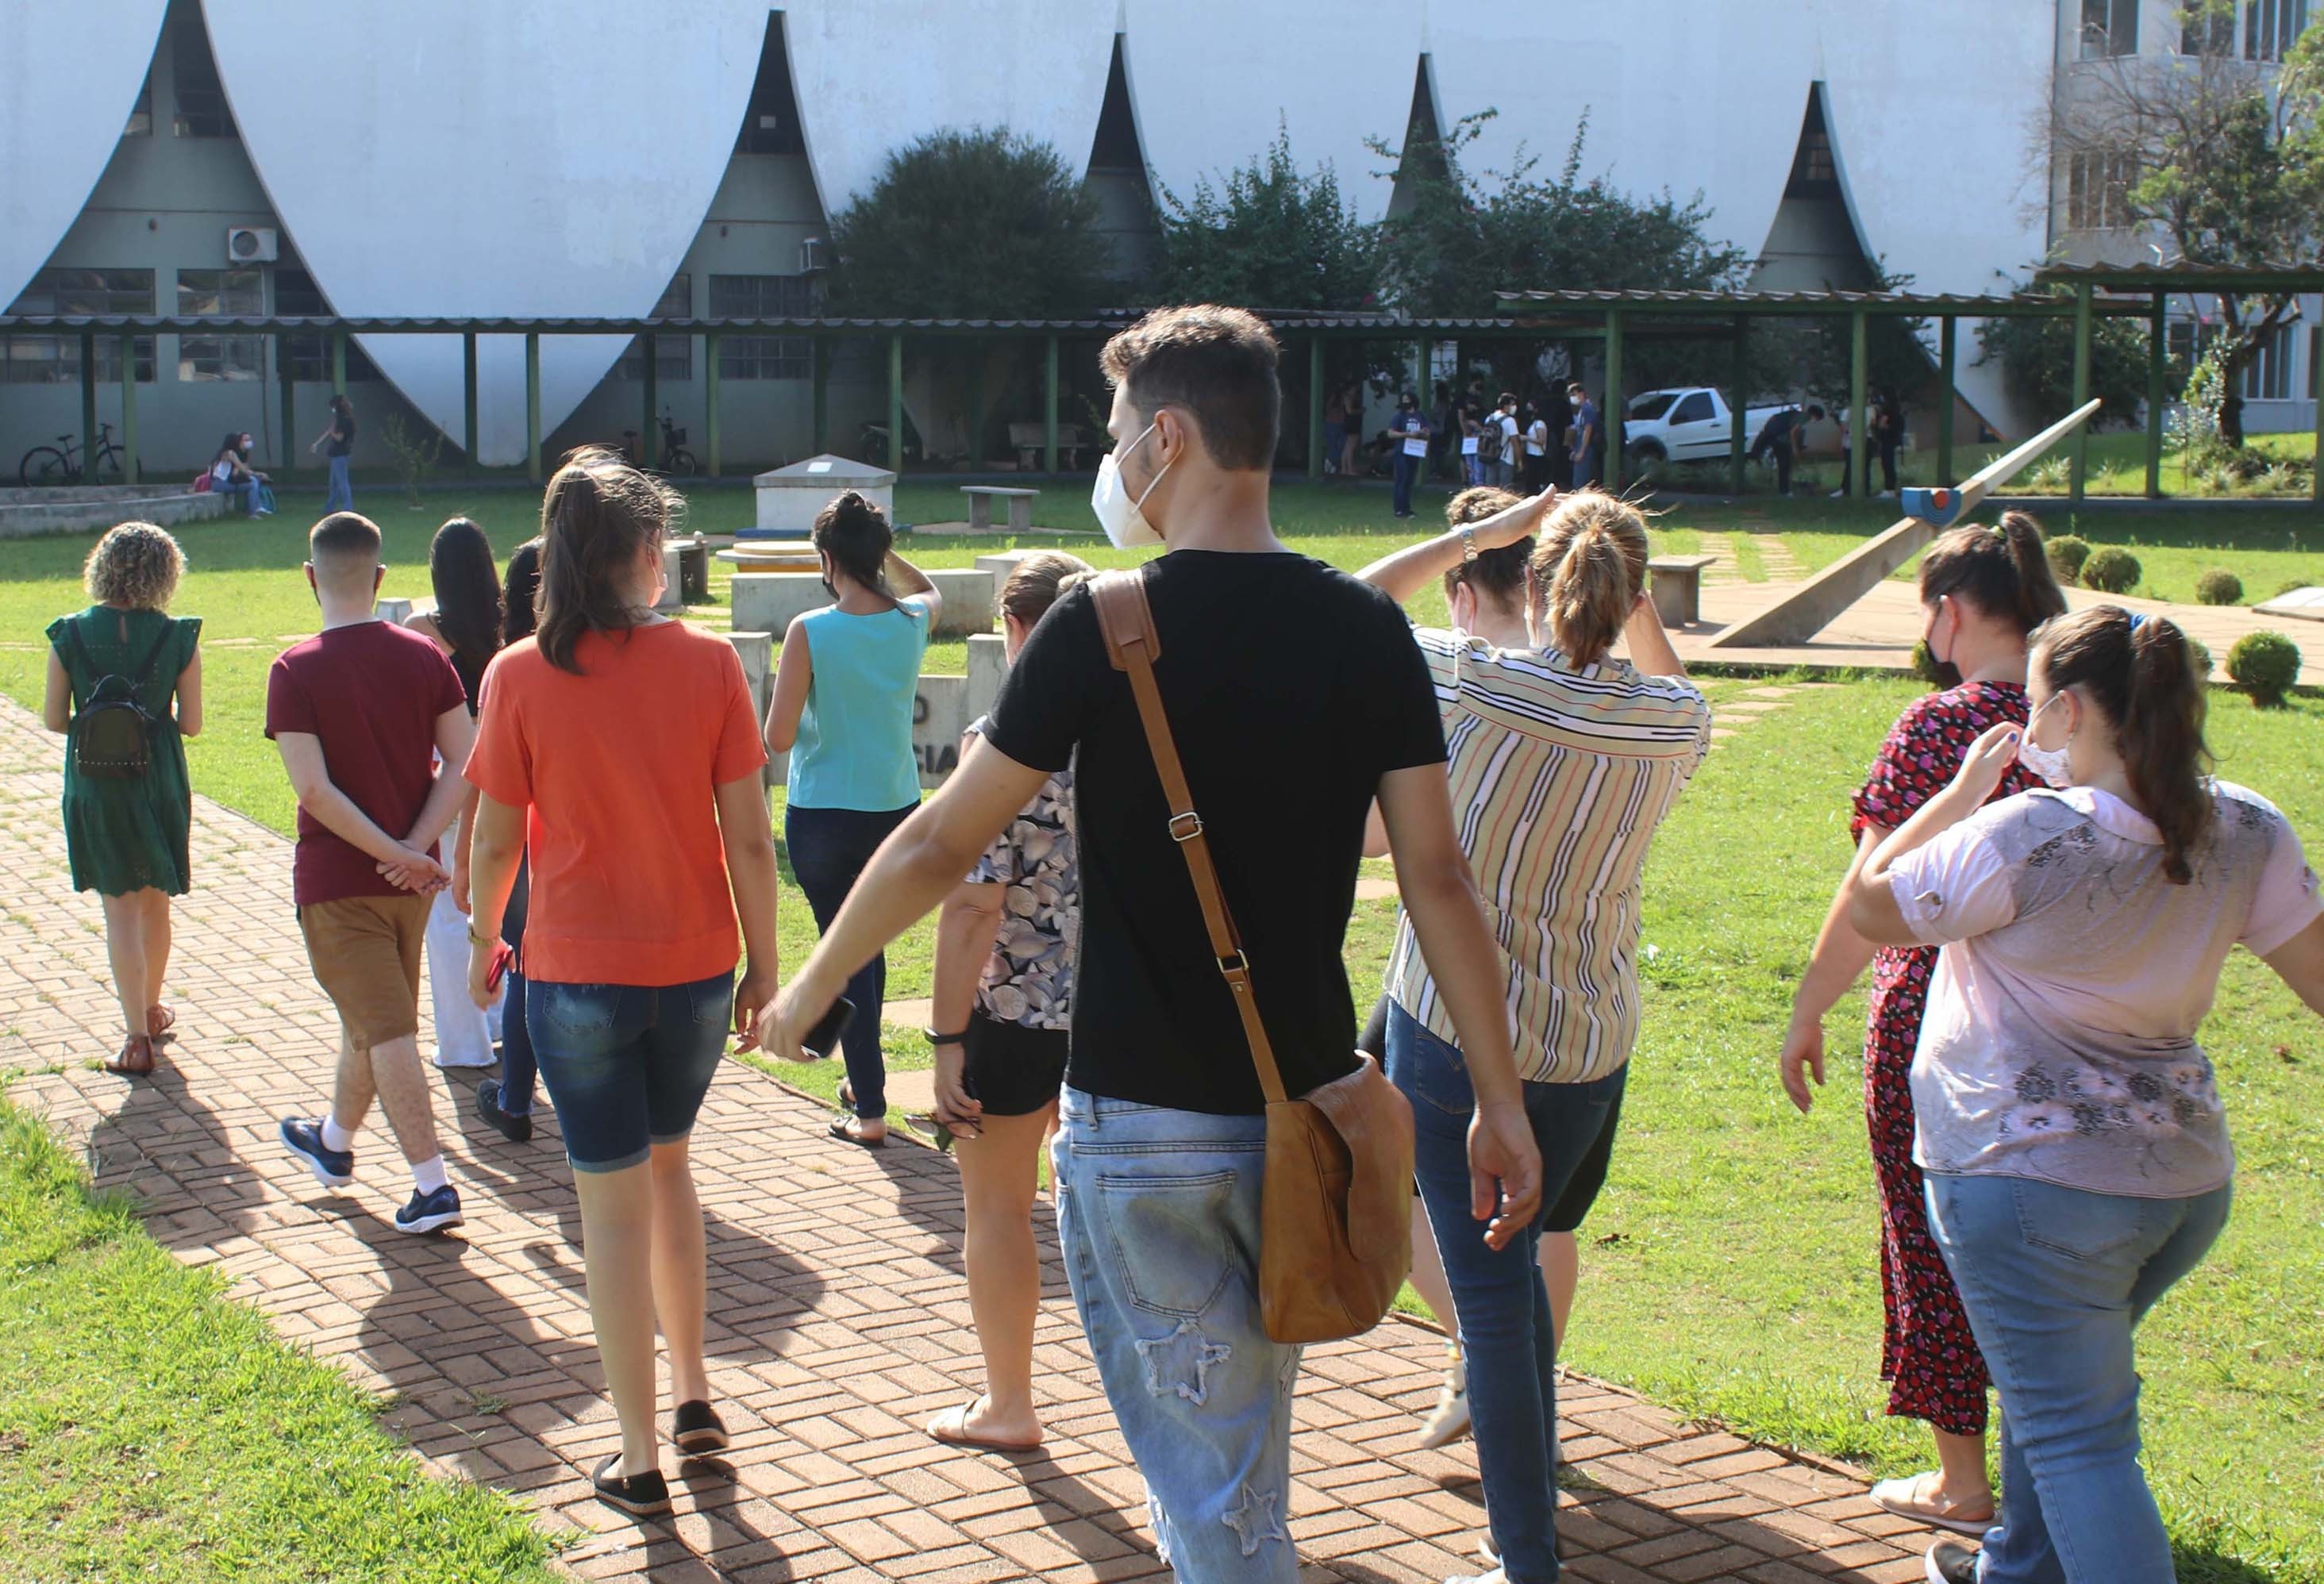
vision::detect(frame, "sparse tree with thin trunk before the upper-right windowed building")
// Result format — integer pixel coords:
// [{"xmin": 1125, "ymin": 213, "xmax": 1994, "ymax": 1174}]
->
[{"xmin": 2052, "ymin": 12, "xmax": 2324, "ymax": 448}]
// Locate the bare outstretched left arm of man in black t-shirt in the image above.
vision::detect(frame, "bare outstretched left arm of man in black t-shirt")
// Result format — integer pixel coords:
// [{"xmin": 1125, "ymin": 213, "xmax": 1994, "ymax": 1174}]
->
[{"xmin": 760, "ymin": 741, "xmax": 1041, "ymax": 1061}]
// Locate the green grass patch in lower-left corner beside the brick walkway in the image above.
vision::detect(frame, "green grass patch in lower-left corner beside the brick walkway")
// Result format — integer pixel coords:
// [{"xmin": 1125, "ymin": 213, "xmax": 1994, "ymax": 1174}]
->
[{"xmin": 0, "ymin": 1101, "xmax": 556, "ymax": 1584}]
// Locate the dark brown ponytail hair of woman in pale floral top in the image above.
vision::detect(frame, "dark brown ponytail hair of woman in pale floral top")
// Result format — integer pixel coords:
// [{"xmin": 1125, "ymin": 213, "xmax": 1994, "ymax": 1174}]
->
[{"xmin": 2034, "ymin": 604, "xmax": 2217, "ymax": 885}]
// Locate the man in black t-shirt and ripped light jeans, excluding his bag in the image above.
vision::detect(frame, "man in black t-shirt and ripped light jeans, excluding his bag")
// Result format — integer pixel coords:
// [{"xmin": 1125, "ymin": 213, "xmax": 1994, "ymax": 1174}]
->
[{"xmin": 764, "ymin": 306, "xmax": 1541, "ymax": 1584}]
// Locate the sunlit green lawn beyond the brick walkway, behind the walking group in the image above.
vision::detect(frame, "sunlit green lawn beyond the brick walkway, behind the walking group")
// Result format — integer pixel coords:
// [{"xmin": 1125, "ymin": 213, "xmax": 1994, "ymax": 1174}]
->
[{"xmin": 0, "ymin": 481, "xmax": 2324, "ymax": 1584}]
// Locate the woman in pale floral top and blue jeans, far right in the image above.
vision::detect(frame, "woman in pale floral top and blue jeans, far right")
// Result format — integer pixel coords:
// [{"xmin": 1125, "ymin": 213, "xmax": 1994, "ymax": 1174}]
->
[{"xmin": 1848, "ymin": 606, "xmax": 2324, "ymax": 1584}]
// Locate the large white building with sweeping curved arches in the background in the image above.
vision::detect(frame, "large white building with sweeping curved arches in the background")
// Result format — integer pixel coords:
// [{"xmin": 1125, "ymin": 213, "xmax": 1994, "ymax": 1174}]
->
[{"xmin": 0, "ymin": 0, "xmax": 2314, "ymax": 474}]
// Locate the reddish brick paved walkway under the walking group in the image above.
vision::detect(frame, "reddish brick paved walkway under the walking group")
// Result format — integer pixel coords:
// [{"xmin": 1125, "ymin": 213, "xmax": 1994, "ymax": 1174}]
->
[{"xmin": 0, "ymin": 699, "xmax": 1926, "ymax": 1584}]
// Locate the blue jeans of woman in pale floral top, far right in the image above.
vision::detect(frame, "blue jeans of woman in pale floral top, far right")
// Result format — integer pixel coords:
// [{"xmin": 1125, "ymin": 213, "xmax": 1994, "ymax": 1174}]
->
[{"xmin": 1929, "ymin": 1173, "xmax": 2234, "ymax": 1584}]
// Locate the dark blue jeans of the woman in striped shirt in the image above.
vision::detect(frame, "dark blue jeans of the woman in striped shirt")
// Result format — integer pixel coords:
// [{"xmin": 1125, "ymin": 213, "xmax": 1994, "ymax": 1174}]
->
[{"xmin": 1387, "ymin": 1005, "xmax": 1629, "ymax": 1584}]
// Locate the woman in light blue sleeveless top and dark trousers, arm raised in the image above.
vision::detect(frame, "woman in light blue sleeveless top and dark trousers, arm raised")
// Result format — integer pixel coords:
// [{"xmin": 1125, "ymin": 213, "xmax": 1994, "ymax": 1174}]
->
[{"xmin": 767, "ymin": 490, "xmax": 944, "ymax": 1148}]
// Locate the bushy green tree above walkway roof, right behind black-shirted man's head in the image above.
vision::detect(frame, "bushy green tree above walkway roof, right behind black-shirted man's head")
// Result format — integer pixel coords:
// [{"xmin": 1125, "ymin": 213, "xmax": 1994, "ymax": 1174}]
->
[{"xmin": 1155, "ymin": 125, "xmax": 1380, "ymax": 309}]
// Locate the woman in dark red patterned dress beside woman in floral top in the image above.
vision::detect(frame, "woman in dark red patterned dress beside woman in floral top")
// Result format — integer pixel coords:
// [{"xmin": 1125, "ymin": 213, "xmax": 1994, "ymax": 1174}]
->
[{"xmin": 1780, "ymin": 511, "xmax": 2066, "ymax": 1533}]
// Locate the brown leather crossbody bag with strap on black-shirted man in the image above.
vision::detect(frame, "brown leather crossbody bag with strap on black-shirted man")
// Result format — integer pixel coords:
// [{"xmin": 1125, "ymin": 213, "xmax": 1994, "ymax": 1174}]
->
[{"xmin": 1090, "ymin": 571, "xmax": 1413, "ymax": 1343}]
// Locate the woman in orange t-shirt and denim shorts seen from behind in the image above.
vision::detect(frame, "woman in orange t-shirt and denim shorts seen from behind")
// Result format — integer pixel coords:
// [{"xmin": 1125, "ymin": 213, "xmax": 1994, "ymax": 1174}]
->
[{"xmin": 467, "ymin": 448, "xmax": 779, "ymax": 1514}]
